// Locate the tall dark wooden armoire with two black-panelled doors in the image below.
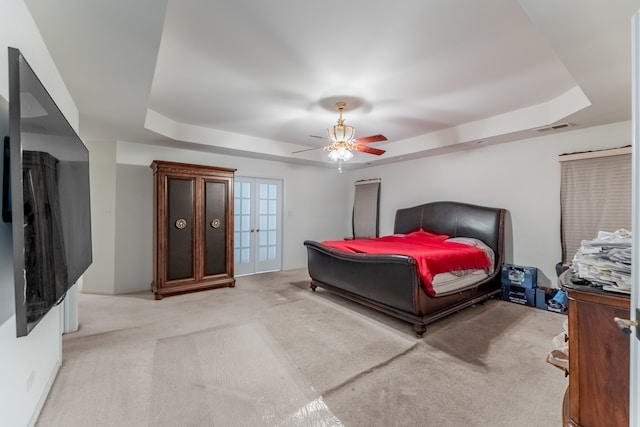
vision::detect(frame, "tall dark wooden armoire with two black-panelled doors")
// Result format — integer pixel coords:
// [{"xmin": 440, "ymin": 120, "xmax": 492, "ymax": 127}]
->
[{"xmin": 151, "ymin": 160, "xmax": 235, "ymax": 299}]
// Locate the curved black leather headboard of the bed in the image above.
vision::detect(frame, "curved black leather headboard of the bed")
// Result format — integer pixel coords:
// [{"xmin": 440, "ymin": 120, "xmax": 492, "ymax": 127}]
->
[{"xmin": 394, "ymin": 202, "xmax": 506, "ymax": 265}]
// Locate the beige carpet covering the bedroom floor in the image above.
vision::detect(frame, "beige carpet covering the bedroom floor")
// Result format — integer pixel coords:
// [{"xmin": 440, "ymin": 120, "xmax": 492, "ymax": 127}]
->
[{"xmin": 37, "ymin": 270, "xmax": 567, "ymax": 427}]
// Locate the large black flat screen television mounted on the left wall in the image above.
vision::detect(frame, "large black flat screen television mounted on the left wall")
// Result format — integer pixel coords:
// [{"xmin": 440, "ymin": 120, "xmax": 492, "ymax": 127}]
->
[{"xmin": 2, "ymin": 48, "xmax": 92, "ymax": 337}]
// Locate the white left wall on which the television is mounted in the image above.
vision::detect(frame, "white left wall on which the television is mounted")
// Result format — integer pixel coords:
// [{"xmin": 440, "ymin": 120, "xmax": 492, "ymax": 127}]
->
[{"xmin": 0, "ymin": 0, "xmax": 78, "ymax": 426}]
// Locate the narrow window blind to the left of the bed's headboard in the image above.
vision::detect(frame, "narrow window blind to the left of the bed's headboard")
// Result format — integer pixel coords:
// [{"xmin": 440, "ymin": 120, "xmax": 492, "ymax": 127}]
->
[{"xmin": 353, "ymin": 179, "xmax": 381, "ymax": 238}]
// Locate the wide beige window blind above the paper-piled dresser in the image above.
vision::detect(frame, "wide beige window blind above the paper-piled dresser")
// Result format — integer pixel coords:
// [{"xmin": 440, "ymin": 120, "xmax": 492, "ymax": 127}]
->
[{"xmin": 559, "ymin": 147, "xmax": 631, "ymax": 264}]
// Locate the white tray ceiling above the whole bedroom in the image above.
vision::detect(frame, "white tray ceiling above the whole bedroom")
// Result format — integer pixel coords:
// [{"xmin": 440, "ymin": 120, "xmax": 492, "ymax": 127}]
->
[{"xmin": 26, "ymin": 0, "xmax": 640, "ymax": 171}]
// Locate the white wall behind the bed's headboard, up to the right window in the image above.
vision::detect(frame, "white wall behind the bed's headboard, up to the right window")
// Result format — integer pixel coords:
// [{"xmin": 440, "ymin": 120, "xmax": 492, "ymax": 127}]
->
[{"xmin": 349, "ymin": 122, "xmax": 631, "ymax": 285}]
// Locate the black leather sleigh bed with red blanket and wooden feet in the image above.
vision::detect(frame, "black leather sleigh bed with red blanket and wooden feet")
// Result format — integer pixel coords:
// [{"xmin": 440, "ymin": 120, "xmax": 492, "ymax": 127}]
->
[{"xmin": 304, "ymin": 202, "xmax": 506, "ymax": 337}]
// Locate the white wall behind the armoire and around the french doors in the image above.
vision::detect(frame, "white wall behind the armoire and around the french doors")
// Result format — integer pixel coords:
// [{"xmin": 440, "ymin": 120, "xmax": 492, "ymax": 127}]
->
[{"xmin": 95, "ymin": 142, "xmax": 351, "ymax": 293}]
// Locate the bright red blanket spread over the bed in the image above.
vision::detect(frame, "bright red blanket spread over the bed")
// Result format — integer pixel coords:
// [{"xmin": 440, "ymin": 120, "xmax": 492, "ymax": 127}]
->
[{"xmin": 322, "ymin": 231, "xmax": 491, "ymax": 296}]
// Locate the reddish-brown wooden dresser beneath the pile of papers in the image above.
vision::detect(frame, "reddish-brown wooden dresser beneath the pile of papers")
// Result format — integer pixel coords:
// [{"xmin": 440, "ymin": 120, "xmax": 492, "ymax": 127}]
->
[{"xmin": 561, "ymin": 280, "xmax": 630, "ymax": 427}]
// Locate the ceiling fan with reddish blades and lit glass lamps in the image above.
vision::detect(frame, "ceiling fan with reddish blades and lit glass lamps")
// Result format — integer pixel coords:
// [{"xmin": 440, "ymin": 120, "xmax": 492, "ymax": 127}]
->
[{"xmin": 293, "ymin": 101, "xmax": 387, "ymax": 172}]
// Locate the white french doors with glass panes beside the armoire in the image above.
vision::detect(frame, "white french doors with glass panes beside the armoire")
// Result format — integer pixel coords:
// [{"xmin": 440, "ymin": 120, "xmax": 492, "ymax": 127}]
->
[{"xmin": 233, "ymin": 176, "xmax": 282, "ymax": 276}]
